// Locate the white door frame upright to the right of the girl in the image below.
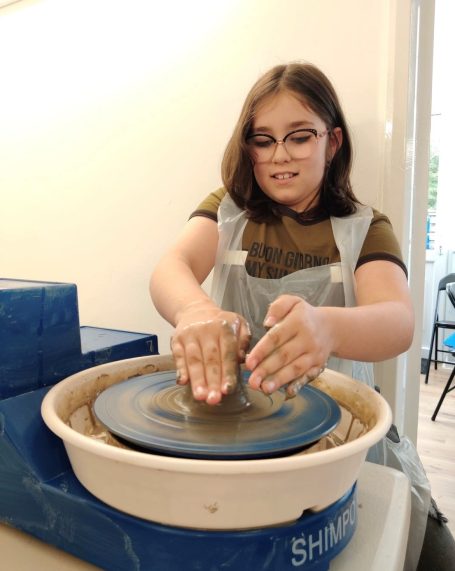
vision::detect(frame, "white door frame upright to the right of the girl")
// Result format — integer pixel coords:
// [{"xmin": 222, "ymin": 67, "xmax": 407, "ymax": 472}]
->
[{"xmin": 376, "ymin": 0, "xmax": 434, "ymax": 441}]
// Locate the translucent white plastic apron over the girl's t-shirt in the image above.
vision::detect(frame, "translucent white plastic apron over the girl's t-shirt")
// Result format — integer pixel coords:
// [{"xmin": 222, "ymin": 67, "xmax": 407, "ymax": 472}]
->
[{"xmin": 211, "ymin": 195, "xmax": 374, "ymax": 388}]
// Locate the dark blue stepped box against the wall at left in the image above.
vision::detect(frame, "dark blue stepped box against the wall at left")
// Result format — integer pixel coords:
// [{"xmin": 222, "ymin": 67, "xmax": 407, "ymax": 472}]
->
[{"xmin": 0, "ymin": 278, "xmax": 158, "ymax": 399}]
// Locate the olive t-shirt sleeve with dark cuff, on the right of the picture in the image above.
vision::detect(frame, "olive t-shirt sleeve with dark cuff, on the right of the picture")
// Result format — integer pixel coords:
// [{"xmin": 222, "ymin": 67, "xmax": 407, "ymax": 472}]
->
[{"xmin": 357, "ymin": 210, "xmax": 408, "ymax": 276}]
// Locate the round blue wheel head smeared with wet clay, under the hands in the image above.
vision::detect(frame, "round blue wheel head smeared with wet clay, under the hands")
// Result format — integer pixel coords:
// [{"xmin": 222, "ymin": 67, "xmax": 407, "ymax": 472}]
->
[{"xmin": 94, "ymin": 371, "xmax": 341, "ymax": 460}]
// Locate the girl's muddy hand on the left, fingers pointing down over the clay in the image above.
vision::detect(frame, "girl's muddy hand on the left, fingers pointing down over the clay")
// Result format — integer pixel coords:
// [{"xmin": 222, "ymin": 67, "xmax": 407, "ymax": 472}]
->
[{"xmin": 171, "ymin": 300, "xmax": 251, "ymax": 404}]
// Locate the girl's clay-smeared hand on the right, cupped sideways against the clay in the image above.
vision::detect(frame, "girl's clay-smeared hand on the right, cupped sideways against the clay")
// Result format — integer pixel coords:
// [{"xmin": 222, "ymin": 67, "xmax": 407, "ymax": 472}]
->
[{"xmin": 245, "ymin": 295, "xmax": 332, "ymax": 396}]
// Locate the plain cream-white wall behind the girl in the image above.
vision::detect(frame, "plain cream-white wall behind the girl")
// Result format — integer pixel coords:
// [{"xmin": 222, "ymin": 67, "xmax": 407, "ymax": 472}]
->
[{"xmin": 0, "ymin": 0, "xmax": 432, "ymax": 438}]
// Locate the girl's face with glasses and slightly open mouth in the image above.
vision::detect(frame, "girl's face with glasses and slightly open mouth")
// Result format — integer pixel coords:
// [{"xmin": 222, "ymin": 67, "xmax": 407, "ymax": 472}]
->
[{"xmin": 248, "ymin": 92, "xmax": 341, "ymax": 212}]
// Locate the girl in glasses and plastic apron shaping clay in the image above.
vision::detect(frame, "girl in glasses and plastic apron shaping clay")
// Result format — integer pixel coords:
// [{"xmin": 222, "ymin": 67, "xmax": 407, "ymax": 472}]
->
[{"xmin": 151, "ymin": 63, "xmax": 414, "ymax": 404}]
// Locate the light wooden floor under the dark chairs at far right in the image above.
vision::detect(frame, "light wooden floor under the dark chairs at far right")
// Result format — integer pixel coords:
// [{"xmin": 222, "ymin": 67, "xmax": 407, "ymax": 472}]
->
[{"xmin": 417, "ymin": 365, "xmax": 455, "ymax": 535}]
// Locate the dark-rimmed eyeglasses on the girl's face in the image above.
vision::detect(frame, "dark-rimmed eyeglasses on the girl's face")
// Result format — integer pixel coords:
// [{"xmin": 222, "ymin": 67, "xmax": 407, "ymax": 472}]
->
[{"xmin": 246, "ymin": 129, "xmax": 330, "ymax": 163}]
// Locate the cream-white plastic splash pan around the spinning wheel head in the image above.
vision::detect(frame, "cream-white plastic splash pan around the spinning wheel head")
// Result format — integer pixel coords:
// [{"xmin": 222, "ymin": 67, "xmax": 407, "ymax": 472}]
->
[{"xmin": 41, "ymin": 356, "xmax": 392, "ymax": 530}]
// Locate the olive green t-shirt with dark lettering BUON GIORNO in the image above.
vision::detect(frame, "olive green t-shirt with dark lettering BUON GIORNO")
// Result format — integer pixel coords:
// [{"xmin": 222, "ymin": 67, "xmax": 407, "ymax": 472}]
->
[{"xmin": 191, "ymin": 188, "xmax": 407, "ymax": 278}]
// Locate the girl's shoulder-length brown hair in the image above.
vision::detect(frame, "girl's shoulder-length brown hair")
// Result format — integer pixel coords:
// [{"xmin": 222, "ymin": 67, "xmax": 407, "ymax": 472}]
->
[{"xmin": 221, "ymin": 63, "xmax": 359, "ymax": 222}]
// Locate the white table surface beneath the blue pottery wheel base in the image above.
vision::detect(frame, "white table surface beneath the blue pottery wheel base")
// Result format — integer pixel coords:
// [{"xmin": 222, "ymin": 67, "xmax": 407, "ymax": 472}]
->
[{"xmin": 0, "ymin": 462, "xmax": 411, "ymax": 571}]
